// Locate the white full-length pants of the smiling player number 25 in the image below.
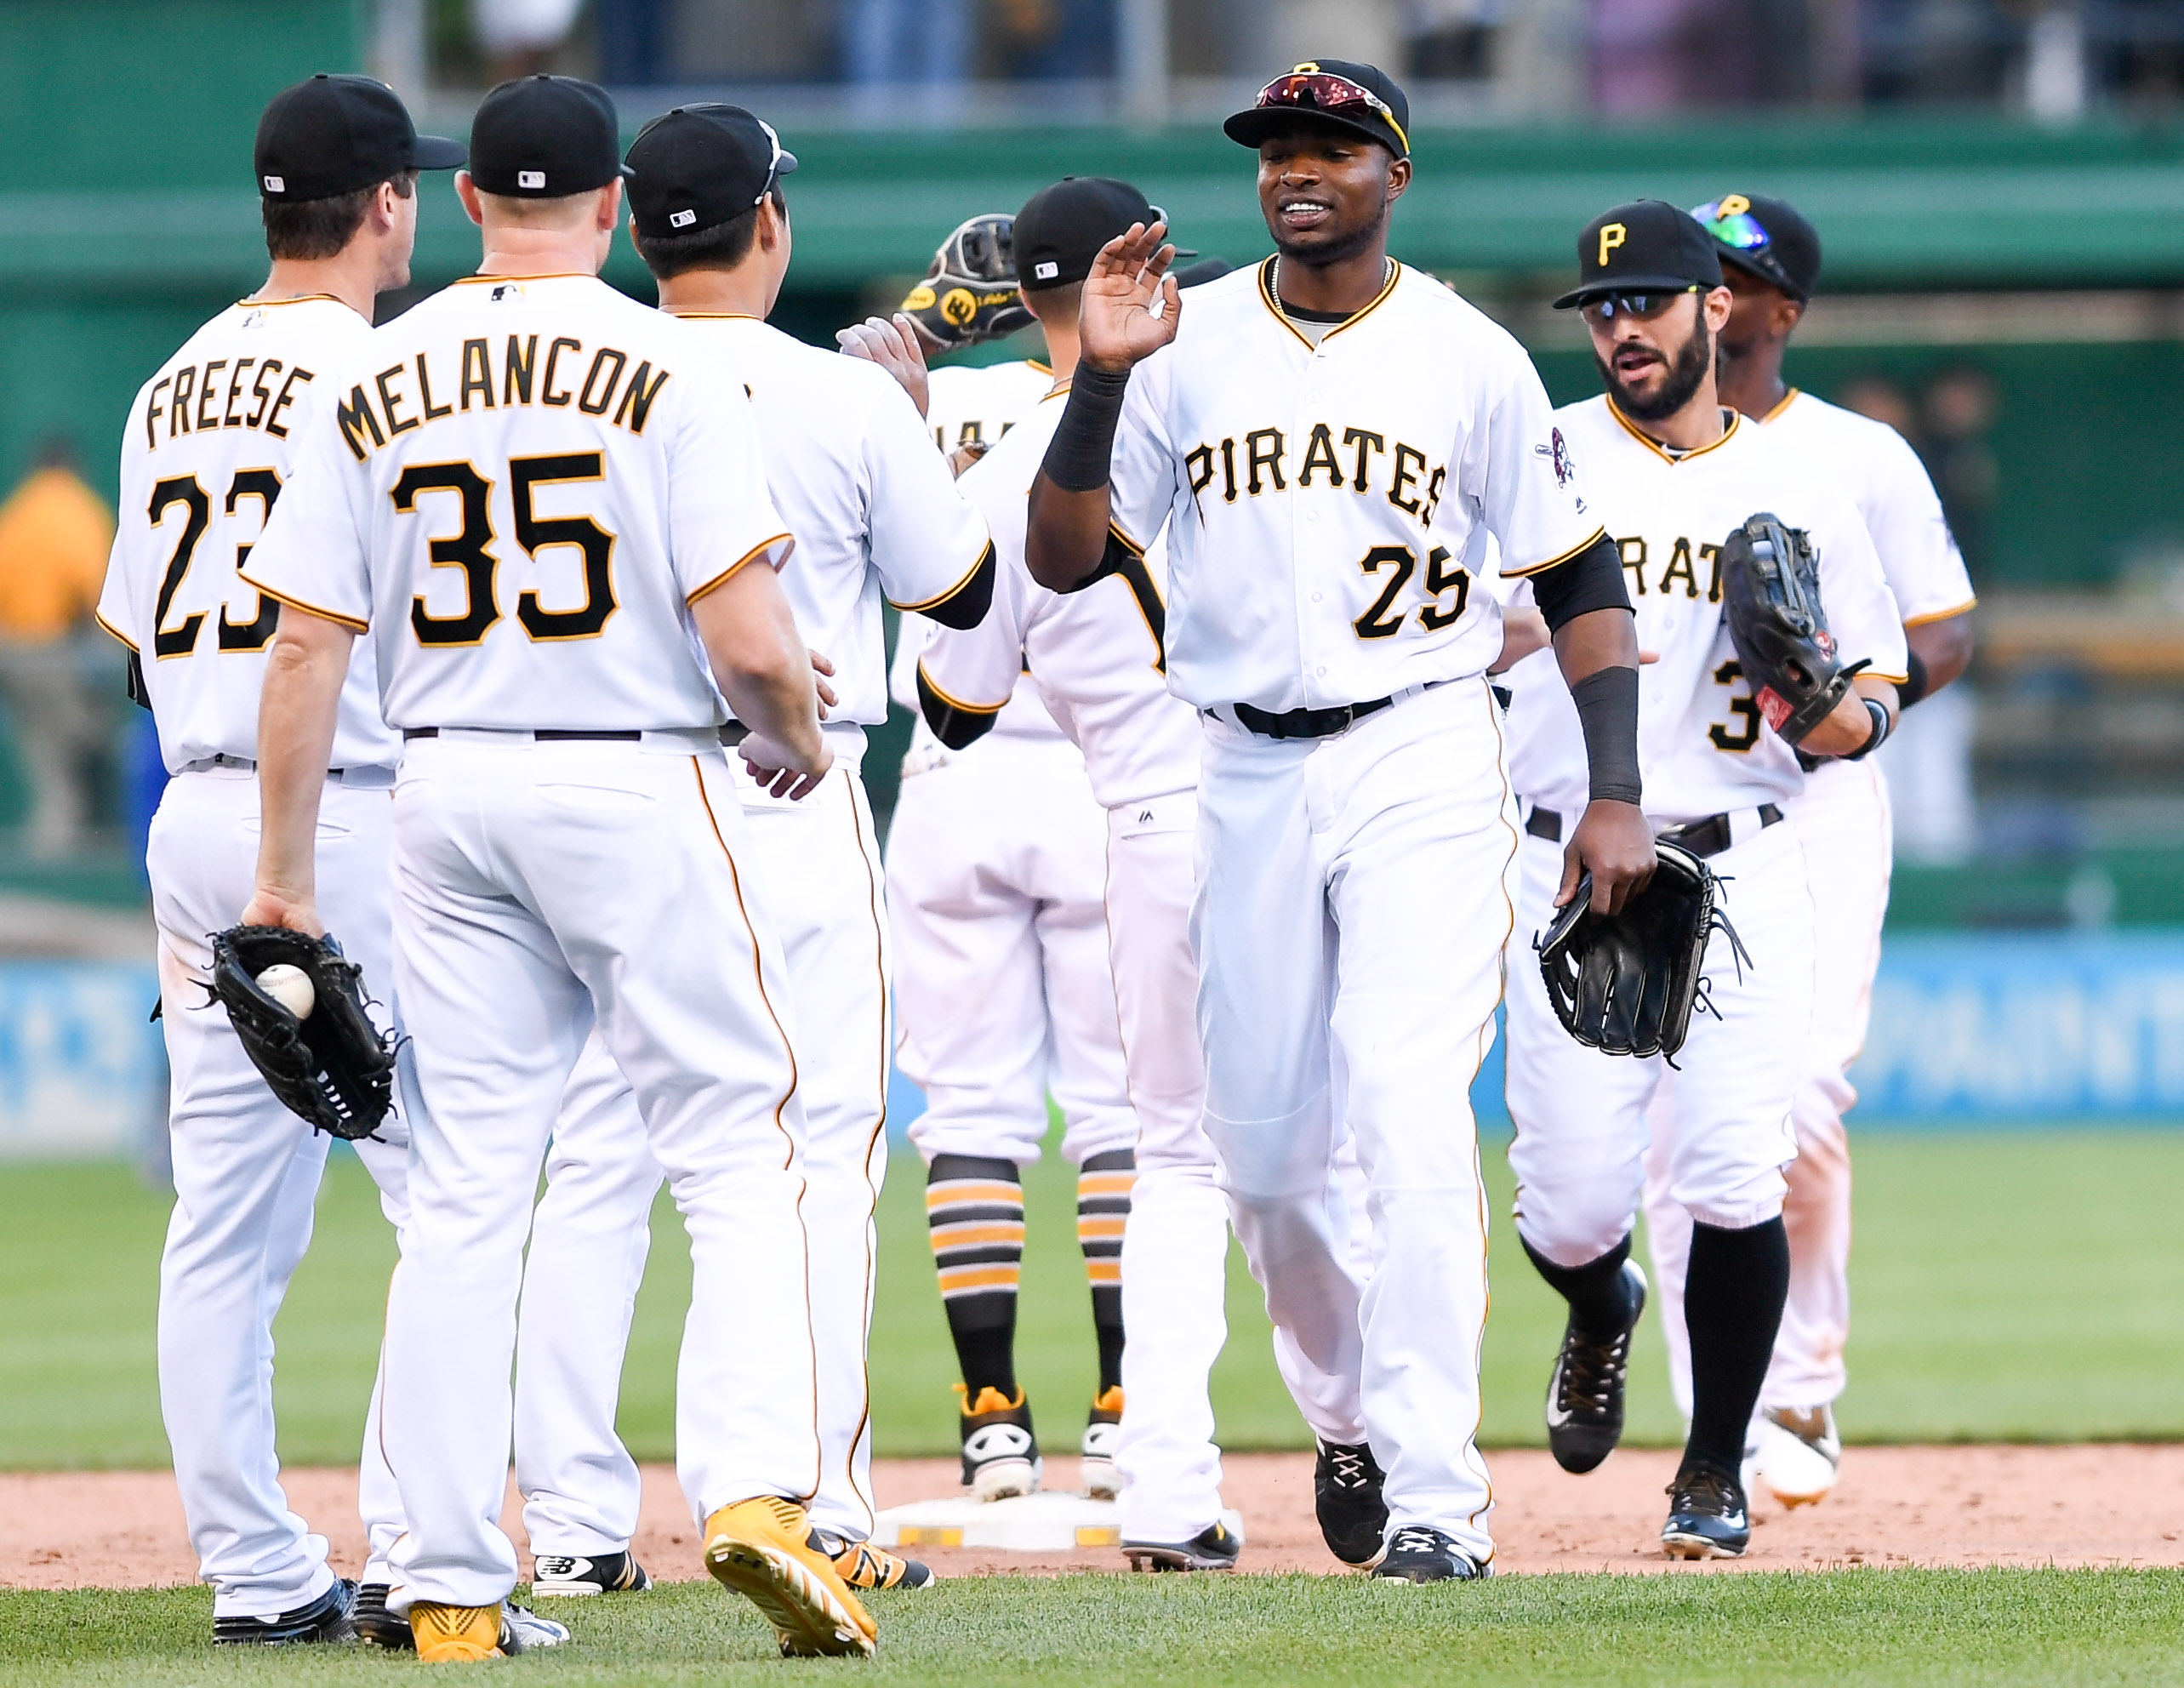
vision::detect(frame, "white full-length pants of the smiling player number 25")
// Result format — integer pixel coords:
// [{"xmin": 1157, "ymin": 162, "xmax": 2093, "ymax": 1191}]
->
[{"xmin": 1190, "ymin": 679, "xmax": 1515, "ymax": 1561}]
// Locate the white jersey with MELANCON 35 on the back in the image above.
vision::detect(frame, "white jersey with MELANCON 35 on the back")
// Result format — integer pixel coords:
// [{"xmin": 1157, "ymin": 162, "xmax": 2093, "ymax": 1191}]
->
[{"xmin": 245, "ymin": 275, "xmax": 793, "ymax": 732}]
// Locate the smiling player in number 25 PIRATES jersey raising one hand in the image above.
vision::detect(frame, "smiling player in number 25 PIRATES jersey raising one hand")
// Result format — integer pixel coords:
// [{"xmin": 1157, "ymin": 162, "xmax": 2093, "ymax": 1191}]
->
[{"xmin": 1024, "ymin": 59, "xmax": 1653, "ymax": 1581}]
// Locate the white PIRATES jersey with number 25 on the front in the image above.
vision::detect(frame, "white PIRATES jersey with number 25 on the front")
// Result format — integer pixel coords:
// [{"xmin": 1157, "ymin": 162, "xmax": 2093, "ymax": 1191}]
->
[{"xmin": 1112, "ymin": 258, "xmax": 1601, "ymax": 712}]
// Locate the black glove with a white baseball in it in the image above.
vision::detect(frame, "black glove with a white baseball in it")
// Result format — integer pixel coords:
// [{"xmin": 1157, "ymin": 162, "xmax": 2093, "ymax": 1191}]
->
[{"xmin": 209, "ymin": 926, "xmax": 396, "ymax": 1140}]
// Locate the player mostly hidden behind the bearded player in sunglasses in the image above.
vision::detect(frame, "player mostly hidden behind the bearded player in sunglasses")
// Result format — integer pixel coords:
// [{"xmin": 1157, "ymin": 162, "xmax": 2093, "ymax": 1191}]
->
[{"xmin": 1647, "ymin": 194, "xmax": 1972, "ymax": 1507}]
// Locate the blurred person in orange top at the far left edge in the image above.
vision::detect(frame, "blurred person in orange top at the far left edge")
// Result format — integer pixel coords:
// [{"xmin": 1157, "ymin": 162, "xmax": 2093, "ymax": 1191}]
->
[{"xmin": 0, "ymin": 439, "xmax": 113, "ymax": 856}]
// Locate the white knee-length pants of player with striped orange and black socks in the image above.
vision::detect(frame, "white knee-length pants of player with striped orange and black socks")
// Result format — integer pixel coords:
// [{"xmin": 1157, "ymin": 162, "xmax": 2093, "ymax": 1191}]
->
[{"xmin": 887, "ymin": 736, "xmax": 1138, "ymax": 1170}]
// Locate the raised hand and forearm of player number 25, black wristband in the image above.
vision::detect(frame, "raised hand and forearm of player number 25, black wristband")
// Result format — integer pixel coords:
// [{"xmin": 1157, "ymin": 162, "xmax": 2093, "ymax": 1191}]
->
[{"xmin": 1024, "ymin": 223, "xmax": 1183, "ymax": 592}]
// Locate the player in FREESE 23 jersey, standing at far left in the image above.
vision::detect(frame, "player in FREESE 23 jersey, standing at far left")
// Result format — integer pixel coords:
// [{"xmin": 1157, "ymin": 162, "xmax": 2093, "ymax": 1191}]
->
[{"xmin": 99, "ymin": 77, "xmax": 463, "ymax": 1642}]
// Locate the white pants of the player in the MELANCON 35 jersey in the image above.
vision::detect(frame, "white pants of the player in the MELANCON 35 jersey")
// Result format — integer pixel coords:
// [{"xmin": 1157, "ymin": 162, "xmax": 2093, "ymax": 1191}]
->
[{"xmin": 382, "ymin": 729, "xmax": 819, "ymax": 1611}]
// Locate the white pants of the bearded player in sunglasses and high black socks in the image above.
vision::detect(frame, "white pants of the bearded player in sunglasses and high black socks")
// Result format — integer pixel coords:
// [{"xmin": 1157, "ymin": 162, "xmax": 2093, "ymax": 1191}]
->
[{"xmin": 1509, "ymin": 821, "xmax": 1813, "ymax": 1275}]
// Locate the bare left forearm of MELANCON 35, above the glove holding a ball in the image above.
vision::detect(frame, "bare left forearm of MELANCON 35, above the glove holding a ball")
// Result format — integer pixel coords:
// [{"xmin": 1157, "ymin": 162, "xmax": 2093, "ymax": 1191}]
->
[{"xmin": 240, "ymin": 605, "xmax": 356, "ymax": 937}]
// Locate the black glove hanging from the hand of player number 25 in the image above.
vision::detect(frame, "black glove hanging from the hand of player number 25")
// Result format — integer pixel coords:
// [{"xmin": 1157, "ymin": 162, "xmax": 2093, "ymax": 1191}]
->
[{"xmin": 1533, "ymin": 843, "xmax": 1748, "ymax": 1057}]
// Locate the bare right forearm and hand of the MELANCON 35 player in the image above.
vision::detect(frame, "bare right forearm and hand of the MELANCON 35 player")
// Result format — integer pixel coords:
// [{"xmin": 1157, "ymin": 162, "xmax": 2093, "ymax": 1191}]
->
[{"xmin": 690, "ymin": 562, "xmax": 835, "ymax": 797}]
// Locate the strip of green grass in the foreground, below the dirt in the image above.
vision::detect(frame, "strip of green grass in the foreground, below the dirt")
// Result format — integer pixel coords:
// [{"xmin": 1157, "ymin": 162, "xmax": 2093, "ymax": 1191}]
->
[{"xmin": 0, "ymin": 1570, "xmax": 2184, "ymax": 1688}]
